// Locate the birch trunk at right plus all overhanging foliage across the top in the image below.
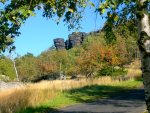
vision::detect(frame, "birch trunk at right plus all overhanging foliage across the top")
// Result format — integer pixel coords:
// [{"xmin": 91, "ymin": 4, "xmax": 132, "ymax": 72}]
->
[{"xmin": 0, "ymin": 0, "xmax": 150, "ymax": 112}]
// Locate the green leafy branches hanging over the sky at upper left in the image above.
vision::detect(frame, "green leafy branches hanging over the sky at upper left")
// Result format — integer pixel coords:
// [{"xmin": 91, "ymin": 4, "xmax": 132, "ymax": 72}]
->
[{"xmin": 0, "ymin": 0, "xmax": 87, "ymax": 52}]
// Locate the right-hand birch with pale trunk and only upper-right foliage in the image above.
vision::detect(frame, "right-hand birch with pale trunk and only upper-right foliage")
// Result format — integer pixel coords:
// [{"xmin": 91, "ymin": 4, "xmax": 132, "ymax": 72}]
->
[{"xmin": 98, "ymin": 0, "xmax": 150, "ymax": 113}]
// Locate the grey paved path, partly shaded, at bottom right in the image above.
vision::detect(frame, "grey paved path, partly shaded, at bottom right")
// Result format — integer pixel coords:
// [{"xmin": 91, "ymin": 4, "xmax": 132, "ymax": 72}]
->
[{"xmin": 57, "ymin": 89, "xmax": 145, "ymax": 113}]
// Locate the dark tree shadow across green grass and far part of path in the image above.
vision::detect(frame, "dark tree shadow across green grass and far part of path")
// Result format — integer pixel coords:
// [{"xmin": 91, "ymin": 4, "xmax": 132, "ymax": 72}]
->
[{"xmin": 63, "ymin": 85, "xmax": 144, "ymax": 103}]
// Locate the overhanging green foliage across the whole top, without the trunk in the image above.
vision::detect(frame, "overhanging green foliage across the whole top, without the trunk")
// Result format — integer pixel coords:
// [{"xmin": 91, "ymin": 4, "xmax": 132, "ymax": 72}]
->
[{"xmin": 0, "ymin": 0, "xmax": 150, "ymax": 51}]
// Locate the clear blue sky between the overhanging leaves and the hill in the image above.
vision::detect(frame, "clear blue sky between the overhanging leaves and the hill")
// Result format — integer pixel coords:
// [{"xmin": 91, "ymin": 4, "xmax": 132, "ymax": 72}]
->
[{"xmin": 14, "ymin": 9, "xmax": 105, "ymax": 56}]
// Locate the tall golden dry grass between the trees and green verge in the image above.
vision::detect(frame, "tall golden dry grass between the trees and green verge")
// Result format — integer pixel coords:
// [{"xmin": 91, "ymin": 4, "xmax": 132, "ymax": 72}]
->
[{"xmin": 0, "ymin": 77, "xmax": 120, "ymax": 113}]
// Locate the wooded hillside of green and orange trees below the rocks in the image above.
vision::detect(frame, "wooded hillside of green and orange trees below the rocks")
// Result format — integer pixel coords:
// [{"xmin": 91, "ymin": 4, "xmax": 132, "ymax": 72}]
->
[{"xmin": 0, "ymin": 28, "xmax": 138, "ymax": 82}]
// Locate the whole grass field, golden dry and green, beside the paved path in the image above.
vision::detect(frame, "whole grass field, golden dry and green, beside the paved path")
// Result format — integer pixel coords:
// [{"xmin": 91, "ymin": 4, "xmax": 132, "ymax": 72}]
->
[{"xmin": 0, "ymin": 77, "xmax": 142, "ymax": 113}]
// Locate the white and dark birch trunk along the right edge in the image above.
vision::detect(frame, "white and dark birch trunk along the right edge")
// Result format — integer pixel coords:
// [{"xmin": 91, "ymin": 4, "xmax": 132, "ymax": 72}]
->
[{"xmin": 137, "ymin": 0, "xmax": 150, "ymax": 113}]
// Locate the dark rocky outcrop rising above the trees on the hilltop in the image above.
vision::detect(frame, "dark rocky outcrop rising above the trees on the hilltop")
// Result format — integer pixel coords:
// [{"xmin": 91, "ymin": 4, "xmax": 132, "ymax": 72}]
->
[{"xmin": 54, "ymin": 32, "xmax": 87, "ymax": 50}]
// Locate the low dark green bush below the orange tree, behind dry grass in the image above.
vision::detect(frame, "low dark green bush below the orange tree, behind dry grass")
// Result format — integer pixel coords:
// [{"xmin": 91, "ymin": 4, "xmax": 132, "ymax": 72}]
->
[{"xmin": 98, "ymin": 66, "xmax": 127, "ymax": 76}]
